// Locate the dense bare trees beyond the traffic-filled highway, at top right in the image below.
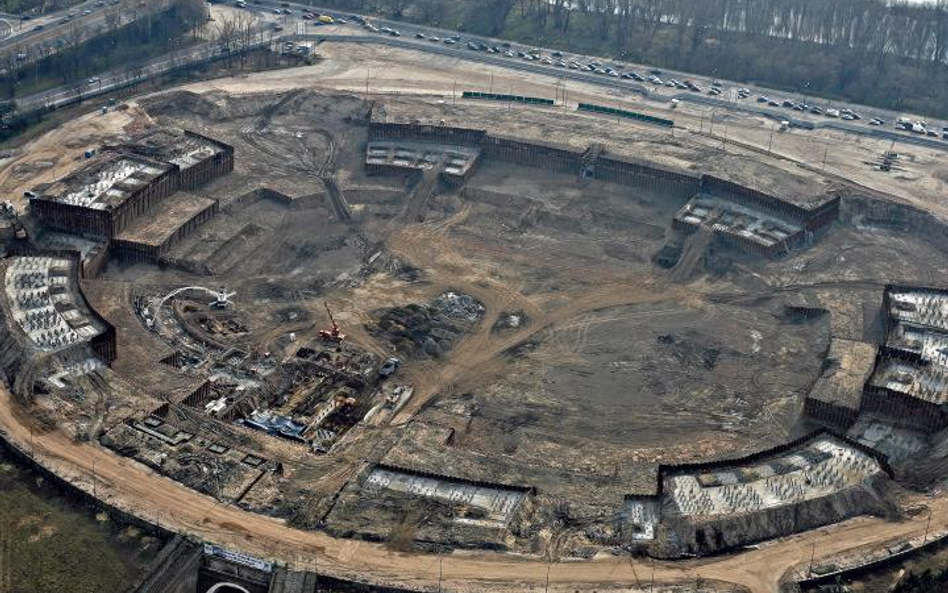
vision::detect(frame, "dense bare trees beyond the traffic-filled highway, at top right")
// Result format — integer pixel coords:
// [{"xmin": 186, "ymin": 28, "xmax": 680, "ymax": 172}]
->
[{"xmin": 298, "ymin": 0, "xmax": 948, "ymax": 117}]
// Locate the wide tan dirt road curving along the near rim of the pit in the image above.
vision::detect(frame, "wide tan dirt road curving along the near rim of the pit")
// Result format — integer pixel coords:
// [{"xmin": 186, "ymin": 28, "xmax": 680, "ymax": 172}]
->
[{"xmin": 0, "ymin": 388, "xmax": 948, "ymax": 593}]
